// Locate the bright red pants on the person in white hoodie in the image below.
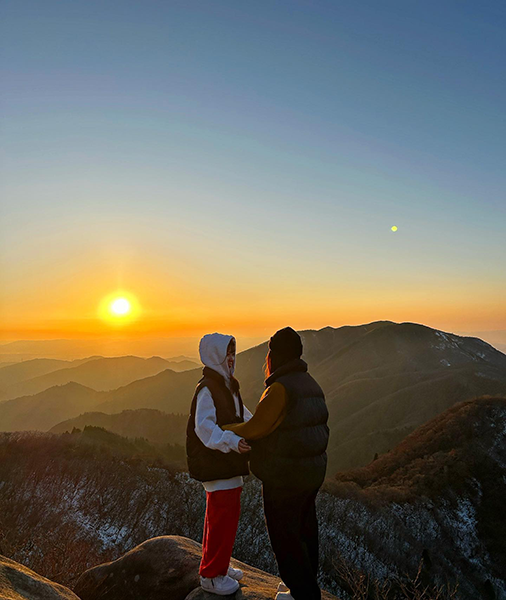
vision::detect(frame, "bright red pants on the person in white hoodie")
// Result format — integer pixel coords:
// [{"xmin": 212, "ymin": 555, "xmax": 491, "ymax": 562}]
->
[{"xmin": 199, "ymin": 487, "xmax": 242, "ymax": 578}]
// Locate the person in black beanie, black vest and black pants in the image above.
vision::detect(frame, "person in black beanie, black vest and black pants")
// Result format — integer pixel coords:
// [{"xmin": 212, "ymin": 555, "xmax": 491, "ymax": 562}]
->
[{"xmin": 224, "ymin": 327, "xmax": 329, "ymax": 600}]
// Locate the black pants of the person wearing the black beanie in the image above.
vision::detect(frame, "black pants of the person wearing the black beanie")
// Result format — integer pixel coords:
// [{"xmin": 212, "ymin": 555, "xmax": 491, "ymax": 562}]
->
[{"xmin": 262, "ymin": 483, "xmax": 321, "ymax": 600}]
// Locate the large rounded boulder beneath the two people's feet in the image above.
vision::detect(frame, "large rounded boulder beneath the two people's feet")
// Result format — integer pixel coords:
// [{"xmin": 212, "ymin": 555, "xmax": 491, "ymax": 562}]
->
[{"xmin": 74, "ymin": 536, "xmax": 334, "ymax": 600}]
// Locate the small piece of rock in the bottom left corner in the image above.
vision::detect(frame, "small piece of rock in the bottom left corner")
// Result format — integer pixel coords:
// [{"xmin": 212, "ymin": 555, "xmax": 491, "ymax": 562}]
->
[{"xmin": 0, "ymin": 555, "xmax": 79, "ymax": 600}]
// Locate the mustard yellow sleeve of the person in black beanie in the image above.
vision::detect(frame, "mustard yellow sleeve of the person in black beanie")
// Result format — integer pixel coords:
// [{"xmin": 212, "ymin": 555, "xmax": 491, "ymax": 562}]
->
[{"xmin": 222, "ymin": 381, "xmax": 287, "ymax": 440}]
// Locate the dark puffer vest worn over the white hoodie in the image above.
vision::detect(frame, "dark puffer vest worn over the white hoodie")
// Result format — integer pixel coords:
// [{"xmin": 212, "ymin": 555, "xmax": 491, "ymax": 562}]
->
[{"xmin": 186, "ymin": 367, "xmax": 249, "ymax": 481}]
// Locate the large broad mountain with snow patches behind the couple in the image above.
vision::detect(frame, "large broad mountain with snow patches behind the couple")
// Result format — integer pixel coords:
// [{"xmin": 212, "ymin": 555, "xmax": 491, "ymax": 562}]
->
[{"xmin": 237, "ymin": 321, "xmax": 506, "ymax": 473}]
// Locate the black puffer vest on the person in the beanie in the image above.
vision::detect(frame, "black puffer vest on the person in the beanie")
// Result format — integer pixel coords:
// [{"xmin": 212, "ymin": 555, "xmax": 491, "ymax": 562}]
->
[{"xmin": 250, "ymin": 358, "xmax": 329, "ymax": 490}]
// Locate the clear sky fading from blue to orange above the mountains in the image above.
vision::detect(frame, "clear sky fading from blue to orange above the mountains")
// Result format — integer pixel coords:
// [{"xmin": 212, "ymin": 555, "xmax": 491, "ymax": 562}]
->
[{"xmin": 0, "ymin": 0, "xmax": 506, "ymax": 339}]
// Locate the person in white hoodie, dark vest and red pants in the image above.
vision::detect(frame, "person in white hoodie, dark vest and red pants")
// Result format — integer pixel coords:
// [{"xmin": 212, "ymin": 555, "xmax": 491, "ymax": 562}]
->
[{"xmin": 186, "ymin": 333, "xmax": 252, "ymax": 596}]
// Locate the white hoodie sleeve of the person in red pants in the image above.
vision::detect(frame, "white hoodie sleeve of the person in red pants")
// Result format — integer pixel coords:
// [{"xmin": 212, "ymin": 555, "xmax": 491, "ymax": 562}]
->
[{"xmin": 195, "ymin": 387, "xmax": 242, "ymax": 453}]
